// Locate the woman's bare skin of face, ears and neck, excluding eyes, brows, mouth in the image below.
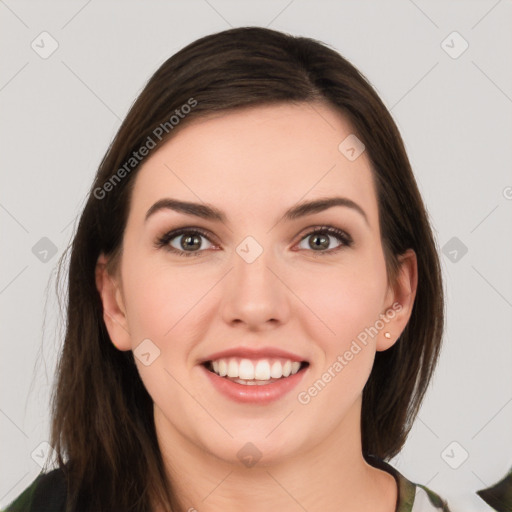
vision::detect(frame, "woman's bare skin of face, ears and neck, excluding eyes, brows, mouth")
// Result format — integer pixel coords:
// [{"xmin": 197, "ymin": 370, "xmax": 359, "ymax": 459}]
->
[{"xmin": 97, "ymin": 103, "xmax": 417, "ymax": 512}]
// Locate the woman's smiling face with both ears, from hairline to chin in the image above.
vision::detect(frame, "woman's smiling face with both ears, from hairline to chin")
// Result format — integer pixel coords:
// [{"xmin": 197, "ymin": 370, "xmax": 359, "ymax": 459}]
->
[{"xmin": 98, "ymin": 103, "xmax": 416, "ymax": 465}]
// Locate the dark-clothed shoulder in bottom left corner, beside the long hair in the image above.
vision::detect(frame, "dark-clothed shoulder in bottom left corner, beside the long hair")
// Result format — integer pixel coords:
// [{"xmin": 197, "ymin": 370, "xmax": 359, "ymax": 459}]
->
[{"xmin": 4, "ymin": 468, "xmax": 67, "ymax": 512}]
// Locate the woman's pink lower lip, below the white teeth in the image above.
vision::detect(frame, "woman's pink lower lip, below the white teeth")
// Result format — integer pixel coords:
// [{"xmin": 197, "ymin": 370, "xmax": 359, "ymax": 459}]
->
[{"xmin": 201, "ymin": 365, "xmax": 308, "ymax": 404}]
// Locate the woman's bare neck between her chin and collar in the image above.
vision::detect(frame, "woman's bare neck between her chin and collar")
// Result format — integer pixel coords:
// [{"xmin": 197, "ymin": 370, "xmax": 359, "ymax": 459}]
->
[{"xmin": 155, "ymin": 401, "xmax": 397, "ymax": 512}]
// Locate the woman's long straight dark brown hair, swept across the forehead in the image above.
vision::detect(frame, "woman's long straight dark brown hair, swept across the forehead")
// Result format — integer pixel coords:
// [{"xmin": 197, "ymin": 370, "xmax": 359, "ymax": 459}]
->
[{"xmin": 51, "ymin": 27, "xmax": 444, "ymax": 512}]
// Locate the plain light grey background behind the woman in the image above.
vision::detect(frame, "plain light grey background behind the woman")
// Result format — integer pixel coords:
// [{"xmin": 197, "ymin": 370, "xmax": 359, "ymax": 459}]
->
[{"xmin": 0, "ymin": 0, "xmax": 512, "ymax": 511}]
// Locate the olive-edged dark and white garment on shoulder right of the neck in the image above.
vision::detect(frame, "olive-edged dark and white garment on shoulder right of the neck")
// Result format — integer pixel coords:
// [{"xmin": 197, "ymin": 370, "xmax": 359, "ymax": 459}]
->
[{"xmin": 368, "ymin": 457, "xmax": 451, "ymax": 512}]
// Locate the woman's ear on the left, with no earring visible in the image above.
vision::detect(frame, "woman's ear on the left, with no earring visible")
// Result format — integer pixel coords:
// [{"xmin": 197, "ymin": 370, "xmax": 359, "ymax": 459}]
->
[{"xmin": 96, "ymin": 253, "xmax": 132, "ymax": 350}]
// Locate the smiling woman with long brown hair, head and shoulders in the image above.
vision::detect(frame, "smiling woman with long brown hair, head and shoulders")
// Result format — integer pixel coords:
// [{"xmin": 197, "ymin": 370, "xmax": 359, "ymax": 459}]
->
[{"xmin": 8, "ymin": 27, "xmax": 448, "ymax": 512}]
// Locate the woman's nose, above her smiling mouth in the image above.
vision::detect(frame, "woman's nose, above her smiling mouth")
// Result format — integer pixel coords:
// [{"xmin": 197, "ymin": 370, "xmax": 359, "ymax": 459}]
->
[{"xmin": 221, "ymin": 245, "xmax": 293, "ymax": 331}]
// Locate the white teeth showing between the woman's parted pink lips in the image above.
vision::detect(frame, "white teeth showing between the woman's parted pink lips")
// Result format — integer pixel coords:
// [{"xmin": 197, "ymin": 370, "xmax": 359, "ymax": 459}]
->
[{"xmin": 202, "ymin": 357, "xmax": 309, "ymax": 386}]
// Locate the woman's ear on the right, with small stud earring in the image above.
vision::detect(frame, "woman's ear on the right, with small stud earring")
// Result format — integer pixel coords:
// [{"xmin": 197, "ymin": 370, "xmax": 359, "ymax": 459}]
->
[{"xmin": 376, "ymin": 249, "xmax": 418, "ymax": 351}]
